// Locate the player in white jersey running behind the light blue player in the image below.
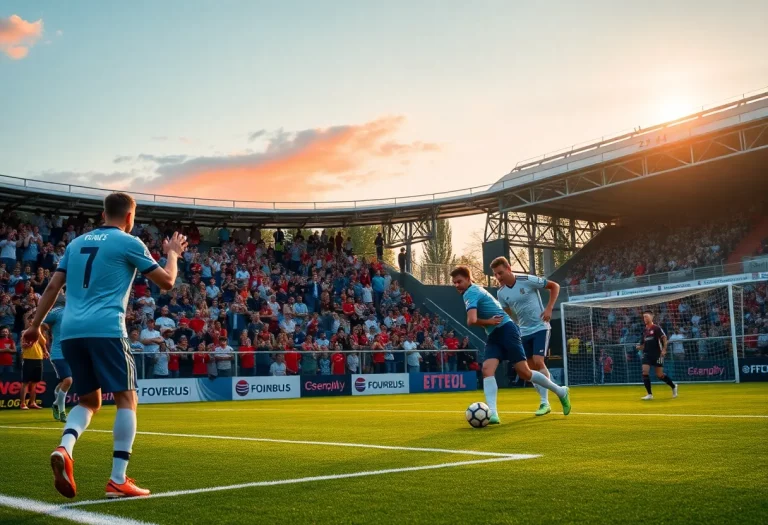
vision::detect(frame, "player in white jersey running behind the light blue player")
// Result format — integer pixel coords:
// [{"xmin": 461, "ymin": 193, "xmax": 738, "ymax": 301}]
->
[{"xmin": 491, "ymin": 257, "xmax": 560, "ymax": 416}]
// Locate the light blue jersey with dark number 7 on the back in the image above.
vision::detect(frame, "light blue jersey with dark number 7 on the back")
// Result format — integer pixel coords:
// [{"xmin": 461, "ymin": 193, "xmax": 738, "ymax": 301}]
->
[{"xmin": 56, "ymin": 226, "xmax": 158, "ymax": 341}]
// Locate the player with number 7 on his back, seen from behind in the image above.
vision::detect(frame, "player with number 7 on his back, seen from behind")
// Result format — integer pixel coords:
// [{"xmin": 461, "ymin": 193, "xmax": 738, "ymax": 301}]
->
[{"xmin": 22, "ymin": 193, "xmax": 187, "ymax": 498}]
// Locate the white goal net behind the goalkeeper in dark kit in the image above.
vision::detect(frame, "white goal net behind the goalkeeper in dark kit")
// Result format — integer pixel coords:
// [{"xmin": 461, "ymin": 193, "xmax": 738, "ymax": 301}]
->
[{"xmin": 561, "ymin": 286, "xmax": 744, "ymax": 385}]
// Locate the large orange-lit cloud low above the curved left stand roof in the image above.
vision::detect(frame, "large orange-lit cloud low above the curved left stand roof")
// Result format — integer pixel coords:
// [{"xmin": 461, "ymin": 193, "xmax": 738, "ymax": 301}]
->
[{"xmin": 146, "ymin": 116, "xmax": 440, "ymax": 202}]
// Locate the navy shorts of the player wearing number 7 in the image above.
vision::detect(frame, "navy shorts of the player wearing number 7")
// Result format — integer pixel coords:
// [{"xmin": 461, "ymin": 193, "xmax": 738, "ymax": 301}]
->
[{"xmin": 61, "ymin": 337, "xmax": 137, "ymax": 396}]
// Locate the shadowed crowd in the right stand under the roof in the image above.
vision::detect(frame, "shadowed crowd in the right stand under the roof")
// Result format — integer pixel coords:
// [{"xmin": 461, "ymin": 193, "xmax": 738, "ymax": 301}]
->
[{"xmin": 563, "ymin": 209, "xmax": 756, "ymax": 287}]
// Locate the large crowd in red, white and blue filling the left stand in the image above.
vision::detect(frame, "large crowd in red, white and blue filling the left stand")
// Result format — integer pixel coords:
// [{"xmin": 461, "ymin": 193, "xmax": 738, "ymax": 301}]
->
[{"xmin": 0, "ymin": 208, "xmax": 478, "ymax": 378}]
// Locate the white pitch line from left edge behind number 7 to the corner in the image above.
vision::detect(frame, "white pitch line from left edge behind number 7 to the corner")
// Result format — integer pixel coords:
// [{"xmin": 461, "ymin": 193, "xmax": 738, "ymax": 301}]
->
[{"xmin": 0, "ymin": 425, "xmax": 538, "ymax": 460}]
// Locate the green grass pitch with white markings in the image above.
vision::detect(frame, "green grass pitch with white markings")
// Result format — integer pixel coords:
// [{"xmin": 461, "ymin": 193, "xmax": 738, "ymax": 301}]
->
[{"xmin": 0, "ymin": 384, "xmax": 768, "ymax": 525}]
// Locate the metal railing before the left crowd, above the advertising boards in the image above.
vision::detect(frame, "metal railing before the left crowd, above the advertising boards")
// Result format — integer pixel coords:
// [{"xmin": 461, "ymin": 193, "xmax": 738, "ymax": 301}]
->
[{"xmin": 133, "ymin": 348, "xmax": 479, "ymax": 379}]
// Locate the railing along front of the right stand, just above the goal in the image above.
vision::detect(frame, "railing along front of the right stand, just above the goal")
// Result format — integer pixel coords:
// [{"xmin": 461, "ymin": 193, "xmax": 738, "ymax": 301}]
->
[{"xmin": 566, "ymin": 255, "xmax": 768, "ymax": 297}]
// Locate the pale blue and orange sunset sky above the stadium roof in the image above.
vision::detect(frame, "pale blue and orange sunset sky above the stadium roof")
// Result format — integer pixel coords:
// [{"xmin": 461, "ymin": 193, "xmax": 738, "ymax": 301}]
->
[{"xmin": 0, "ymin": 0, "xmax": 768, "ymax": 252}]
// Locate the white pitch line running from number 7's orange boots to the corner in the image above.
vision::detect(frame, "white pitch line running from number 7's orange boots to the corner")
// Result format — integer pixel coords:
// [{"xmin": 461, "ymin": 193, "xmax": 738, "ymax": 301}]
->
[{"xmin": 63, "ymin": 449, "xmax": 528, "ymax": 508}]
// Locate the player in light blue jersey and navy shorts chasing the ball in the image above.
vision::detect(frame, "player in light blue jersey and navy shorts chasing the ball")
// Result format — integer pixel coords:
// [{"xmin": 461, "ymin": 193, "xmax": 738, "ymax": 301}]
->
[{"xmin": 451, "ymin": 266, "xmax": 571, "ymax": 424}]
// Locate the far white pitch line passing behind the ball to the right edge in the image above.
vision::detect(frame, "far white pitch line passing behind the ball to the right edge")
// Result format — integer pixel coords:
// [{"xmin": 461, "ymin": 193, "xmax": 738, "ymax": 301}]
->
[{"xmin": 144, "ymin": 405, "xmax": 768, "ymax": 418}]
